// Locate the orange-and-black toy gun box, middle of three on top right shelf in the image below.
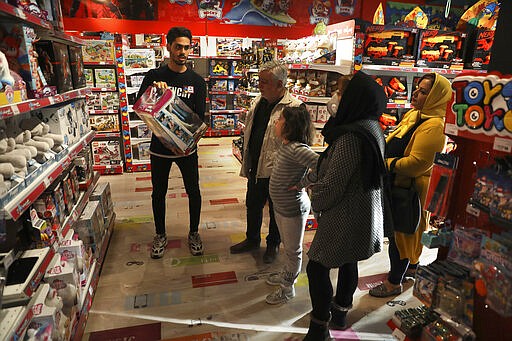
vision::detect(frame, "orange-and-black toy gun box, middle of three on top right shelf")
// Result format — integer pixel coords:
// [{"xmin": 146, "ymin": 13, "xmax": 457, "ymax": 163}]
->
[{"xmin": 416, "ymin": 30, "xmax": 466, "ymax": 70}]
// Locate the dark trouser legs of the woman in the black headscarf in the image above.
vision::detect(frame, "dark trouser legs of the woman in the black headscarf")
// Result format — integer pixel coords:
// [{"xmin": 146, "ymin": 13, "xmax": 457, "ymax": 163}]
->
[{"xmin": 306, "ymin": 260, "xmax": 359, "ymax": 321}]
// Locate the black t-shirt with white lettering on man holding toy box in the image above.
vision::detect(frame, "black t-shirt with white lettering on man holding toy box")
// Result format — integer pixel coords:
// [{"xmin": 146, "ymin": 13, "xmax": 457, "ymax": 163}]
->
[{"xmin": 137, "ymin": 64, "xmax": 206, "ymax": 156}]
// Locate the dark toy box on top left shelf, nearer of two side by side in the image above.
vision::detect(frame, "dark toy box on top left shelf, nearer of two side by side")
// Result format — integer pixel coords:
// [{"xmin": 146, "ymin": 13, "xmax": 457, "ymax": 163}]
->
[{"xmin": 35, "ymin": 40, "xmax": 73, "ymax": 93}]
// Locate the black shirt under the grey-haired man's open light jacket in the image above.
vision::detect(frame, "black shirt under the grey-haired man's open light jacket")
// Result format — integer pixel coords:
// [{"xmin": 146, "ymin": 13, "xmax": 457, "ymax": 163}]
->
[{"xmin": 249, "ymin": 97, "xmax": 282, "ymax": 174}]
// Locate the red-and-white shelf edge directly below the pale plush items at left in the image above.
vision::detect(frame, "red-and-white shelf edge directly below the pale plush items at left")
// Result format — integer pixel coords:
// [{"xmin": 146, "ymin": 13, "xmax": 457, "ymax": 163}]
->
[{"xmin": 4, "ymin": 131, "xmax": 95, "ymax": 220}]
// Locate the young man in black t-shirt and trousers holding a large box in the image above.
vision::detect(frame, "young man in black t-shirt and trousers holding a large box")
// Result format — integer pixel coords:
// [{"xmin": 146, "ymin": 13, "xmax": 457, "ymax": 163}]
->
[{"xmin": 137, "ymin": 27, "xmax": 206, "ymax": 258}]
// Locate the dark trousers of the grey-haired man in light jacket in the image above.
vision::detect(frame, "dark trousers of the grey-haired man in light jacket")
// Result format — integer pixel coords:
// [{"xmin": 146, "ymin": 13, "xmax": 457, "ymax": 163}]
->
[{"xmin": 245, "ymin": 173, "xmax": 281, "ymax": 245}]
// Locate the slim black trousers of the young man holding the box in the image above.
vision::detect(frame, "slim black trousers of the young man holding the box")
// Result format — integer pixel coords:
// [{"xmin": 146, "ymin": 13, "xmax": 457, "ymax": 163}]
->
[{"xmin": 151, "ymin": 153, "xmax": 201, "ymax": 234}]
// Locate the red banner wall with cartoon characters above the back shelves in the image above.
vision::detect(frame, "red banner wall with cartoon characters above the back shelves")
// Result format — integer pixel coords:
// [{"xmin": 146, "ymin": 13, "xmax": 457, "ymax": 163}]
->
[{"xmin": 61, "ymin": 0, "xmax": 488, "ymax": 39}]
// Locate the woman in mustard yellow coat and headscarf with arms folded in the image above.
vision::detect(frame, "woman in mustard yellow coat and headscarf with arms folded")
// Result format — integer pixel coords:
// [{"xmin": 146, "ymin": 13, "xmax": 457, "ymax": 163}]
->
[{"xmin": 370, "ymin": 73, "xmax": 452, "ymax": 297}]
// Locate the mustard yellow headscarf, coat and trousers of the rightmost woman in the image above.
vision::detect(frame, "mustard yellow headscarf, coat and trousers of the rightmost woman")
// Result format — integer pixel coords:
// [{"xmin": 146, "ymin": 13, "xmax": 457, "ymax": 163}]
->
[{"xmin": 386, "ymin": 74, "xmax": 452, "ymax": 264}]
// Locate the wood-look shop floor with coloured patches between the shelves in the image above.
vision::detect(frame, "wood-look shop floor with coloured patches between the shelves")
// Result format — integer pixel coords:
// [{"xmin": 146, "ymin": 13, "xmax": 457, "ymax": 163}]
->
[{"xmin": 84, "ymin": 138, "xmax": 436, "ymax": 340}]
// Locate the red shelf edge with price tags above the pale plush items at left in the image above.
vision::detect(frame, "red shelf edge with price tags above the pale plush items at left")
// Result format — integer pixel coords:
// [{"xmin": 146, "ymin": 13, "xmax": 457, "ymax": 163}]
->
[{"xmin": 0, "ymin": 87, "xmax": 91, "ymax": 120}]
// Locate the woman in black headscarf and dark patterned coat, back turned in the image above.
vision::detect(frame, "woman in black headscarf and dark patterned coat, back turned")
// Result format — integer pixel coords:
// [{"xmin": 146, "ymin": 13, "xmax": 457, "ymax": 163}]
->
[{"xmin": 304, "ymin": 72, "xmax": 386, "ymax": 341}]
